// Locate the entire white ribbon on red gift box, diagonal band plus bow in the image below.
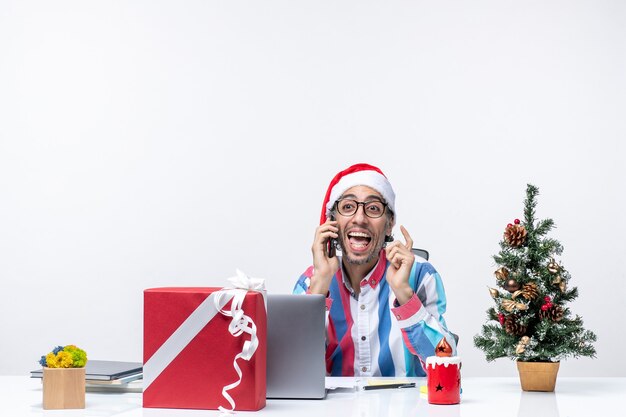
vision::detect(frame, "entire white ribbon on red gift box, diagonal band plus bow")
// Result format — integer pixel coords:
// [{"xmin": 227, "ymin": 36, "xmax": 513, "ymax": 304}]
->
[{"xmin": 143, "ymin": 269, "xmax": 266, "ymax": 412}]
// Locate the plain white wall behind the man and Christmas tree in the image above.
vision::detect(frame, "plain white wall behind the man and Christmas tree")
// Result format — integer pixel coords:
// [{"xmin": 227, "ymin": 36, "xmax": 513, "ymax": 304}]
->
[{"xmin": 0, "ymin": 0, "xmax": 626, "ymax": 376}]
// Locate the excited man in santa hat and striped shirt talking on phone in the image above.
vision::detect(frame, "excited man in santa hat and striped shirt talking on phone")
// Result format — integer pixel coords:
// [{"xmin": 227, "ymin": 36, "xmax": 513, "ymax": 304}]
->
[{"xmin": 294, "ymin": 164, "xmax": 456, "ymax": 376}]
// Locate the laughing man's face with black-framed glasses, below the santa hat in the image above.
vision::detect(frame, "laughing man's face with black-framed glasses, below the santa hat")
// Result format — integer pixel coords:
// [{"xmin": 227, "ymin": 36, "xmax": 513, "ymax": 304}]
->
[{"xmin": 335, "ymin": 185, "xmax": 393, "ymax": 265}]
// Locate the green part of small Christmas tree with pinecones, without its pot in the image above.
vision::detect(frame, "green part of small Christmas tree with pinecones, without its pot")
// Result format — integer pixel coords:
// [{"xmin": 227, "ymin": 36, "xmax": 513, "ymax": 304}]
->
[{"xmin": 474, "ymin": 184, "xmax": 596, "ymax": 362}]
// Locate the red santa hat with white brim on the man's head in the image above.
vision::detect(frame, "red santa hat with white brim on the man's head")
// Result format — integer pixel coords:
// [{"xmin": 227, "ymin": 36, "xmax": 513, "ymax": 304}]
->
[{"xmin": 320, "ymin": 164, "xmax": 396, "ymax": 224}]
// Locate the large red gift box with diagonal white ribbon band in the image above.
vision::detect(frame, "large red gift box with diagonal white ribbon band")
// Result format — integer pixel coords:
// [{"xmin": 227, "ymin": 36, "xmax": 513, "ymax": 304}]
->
[{"xmin": 143, "ymin": 288, "xmax": 267, "ymax": 411}]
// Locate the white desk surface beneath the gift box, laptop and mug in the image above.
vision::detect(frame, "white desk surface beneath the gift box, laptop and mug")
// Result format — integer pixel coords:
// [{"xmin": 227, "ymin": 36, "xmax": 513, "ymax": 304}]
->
[{"xmin": 0, "ymin": 376, "xmax": 626, "ymax": 417}]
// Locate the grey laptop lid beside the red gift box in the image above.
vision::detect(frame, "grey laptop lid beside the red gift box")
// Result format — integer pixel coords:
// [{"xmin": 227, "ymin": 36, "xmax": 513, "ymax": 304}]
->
[{"xmin": 267, "ymin": 294, "xmax": 326, "ymax": 399}]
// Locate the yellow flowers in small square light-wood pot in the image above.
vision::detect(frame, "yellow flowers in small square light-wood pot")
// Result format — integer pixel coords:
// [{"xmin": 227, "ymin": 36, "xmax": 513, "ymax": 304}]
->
[{"xmin": 39, "ymin": 345, "xmax": 87, "ymax": 410}]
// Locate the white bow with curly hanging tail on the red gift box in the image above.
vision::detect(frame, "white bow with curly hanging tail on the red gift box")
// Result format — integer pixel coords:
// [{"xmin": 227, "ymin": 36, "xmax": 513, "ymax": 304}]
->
[{"xmin": 215, "ymin": 269, "xmax": 265, "ymax": 413}]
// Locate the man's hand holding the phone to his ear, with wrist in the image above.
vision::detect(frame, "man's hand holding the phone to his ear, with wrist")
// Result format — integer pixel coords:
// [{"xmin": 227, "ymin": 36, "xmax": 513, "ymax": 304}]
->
[{"xmin": 309, "ymin": 218, "xmax": 339, "ymax": 295}]
